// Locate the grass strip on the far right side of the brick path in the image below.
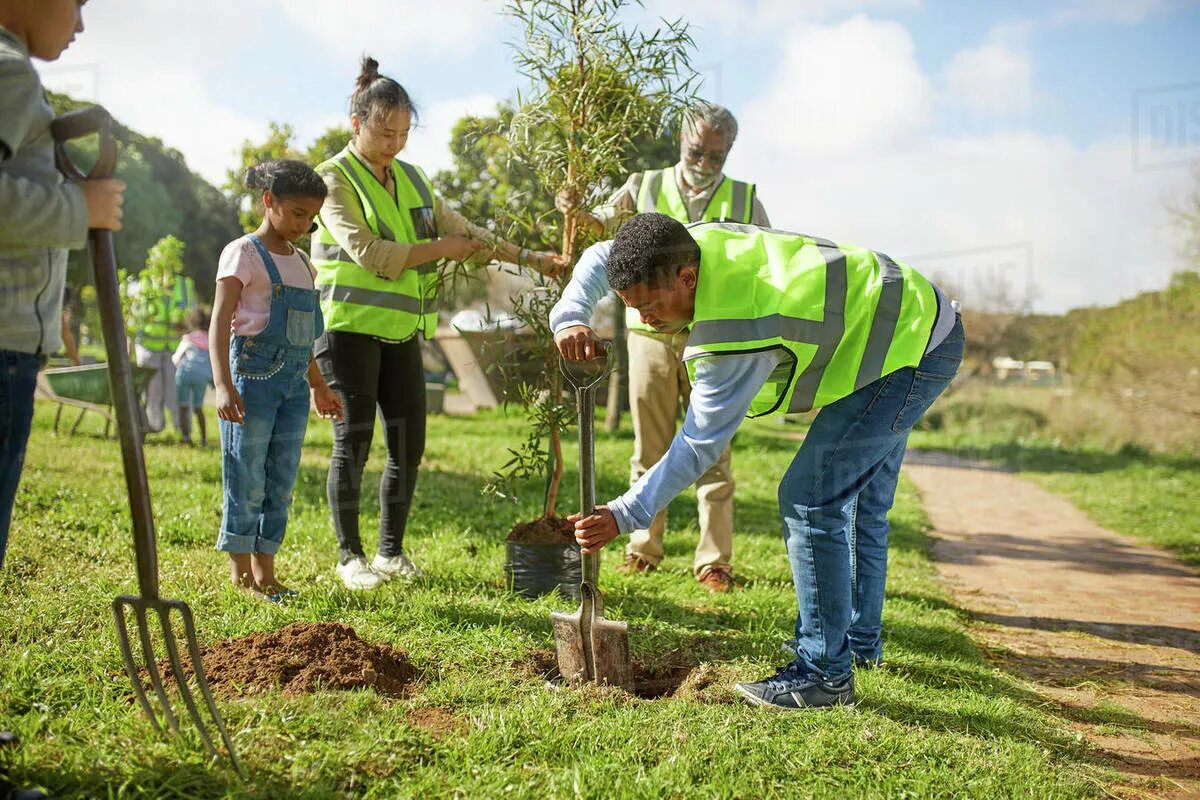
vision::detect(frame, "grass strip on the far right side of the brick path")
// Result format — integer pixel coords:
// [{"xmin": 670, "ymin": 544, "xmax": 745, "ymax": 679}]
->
[{"xmin": 910, "ymin": 387, "xmax": 1200, "ymax": 567}]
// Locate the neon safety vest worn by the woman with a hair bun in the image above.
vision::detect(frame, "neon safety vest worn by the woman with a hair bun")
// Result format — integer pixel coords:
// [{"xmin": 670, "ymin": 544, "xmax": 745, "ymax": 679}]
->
[{"xmin": 312, "ymin": 148, "xmax": 438, "ymax": 341}]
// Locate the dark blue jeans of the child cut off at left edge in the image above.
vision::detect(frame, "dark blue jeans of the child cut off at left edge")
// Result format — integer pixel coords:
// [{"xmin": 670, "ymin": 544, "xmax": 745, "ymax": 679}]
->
[{"xmin": 0, "ymin": 350, "xmax": 42, "ymax": 567}]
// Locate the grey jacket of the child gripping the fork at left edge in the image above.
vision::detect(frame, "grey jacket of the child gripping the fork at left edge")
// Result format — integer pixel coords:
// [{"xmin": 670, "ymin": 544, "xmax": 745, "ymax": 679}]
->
[{"xmin": 0, "ymin": 28, "xmax": 88, "ymax": 353}]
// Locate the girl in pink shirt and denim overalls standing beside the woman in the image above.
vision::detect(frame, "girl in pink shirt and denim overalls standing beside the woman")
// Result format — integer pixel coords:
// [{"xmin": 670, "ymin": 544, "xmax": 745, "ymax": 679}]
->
[{"xmin": 210, "ymin": 161, "xmax": 342, "ymax": 601}]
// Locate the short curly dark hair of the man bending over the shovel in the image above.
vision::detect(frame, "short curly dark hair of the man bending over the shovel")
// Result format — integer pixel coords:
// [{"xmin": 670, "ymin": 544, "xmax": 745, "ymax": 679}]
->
[{"xmin": 605, "ymin": 212, "xmax": 700, "ymax": 291}]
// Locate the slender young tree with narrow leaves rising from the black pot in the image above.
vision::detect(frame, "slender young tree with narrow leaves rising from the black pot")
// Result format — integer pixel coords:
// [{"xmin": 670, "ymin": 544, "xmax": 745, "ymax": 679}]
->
[{"xmin": 480, "ymin": 0, "xmax": 698, "ymax": 517}]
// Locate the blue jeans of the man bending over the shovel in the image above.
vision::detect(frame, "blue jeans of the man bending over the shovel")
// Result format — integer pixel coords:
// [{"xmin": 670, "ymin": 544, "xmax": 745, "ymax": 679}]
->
[{"xmin": 779, "ymin": 321, "xmax": 962, "ymax": 679}]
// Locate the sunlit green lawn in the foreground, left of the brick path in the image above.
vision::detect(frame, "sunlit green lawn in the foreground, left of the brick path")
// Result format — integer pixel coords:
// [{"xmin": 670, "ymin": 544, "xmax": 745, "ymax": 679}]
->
[{"xmin": 0, "ymin": 404, "xmax": 1112, "ymax": 799}]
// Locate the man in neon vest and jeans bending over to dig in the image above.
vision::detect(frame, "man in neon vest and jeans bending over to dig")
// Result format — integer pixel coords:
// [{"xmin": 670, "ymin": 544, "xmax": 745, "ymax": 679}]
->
[{"xmin": 550, "ymin": 213, "xmax": 962, "ymax": 709}]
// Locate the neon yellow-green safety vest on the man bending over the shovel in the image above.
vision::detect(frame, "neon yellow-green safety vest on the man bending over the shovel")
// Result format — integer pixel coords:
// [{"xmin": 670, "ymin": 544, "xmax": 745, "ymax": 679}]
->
[{"xmin": 684, "ymin": 222, "xmax": 937, "ymax": 417}]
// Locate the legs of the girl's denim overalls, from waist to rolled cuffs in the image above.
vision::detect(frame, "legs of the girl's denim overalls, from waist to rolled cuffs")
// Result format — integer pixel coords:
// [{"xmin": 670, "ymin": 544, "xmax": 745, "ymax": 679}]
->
[{"xmin": 217, "ymin": 360, "xmax": 308, "ymax": 555}]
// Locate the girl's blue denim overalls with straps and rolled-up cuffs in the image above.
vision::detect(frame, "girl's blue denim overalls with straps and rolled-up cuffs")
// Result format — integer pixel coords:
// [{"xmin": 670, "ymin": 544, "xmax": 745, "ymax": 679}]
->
[{"xmin": 217, "ymin": 234, "xmax": 324, "ymax": 555}]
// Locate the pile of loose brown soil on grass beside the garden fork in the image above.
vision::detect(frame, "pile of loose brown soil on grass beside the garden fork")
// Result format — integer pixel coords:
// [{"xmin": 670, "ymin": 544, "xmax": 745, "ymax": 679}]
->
[{"xmin": 158, "ymin": 622, "xmax": 418, "ymax": 697}]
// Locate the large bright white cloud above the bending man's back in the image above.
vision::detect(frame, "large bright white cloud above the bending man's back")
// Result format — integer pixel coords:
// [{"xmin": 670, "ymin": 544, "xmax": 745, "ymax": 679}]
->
[{"xmin": 730, "ymin": 18, "xmax": 1188, "ymax": 311}]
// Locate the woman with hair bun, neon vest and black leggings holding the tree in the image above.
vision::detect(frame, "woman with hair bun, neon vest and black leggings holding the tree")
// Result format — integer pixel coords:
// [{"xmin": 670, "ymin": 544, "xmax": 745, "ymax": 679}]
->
[{"xmin": 312, "ymin": 56, "xmax": 564, "ymax": 589}]
